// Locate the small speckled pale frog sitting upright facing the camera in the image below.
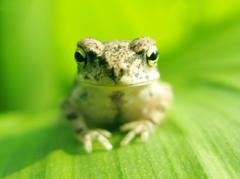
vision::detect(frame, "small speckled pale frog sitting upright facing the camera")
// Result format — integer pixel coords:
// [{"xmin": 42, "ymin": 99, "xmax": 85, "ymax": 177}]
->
[{"xmin": 63, "ymin": 37, "xmax": 173, "ymax": 153}]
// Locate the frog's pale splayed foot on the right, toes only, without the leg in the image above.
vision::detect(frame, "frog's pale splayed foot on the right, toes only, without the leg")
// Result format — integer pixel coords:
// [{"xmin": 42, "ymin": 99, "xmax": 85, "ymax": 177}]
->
[{"xmin": 120, "ymin": 120, "xmax": 155, "ymax": 146}]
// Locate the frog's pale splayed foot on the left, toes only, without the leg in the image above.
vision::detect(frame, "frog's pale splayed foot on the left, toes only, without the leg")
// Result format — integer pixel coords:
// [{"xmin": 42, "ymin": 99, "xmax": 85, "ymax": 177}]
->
[{"xmin": 78, "ymin": 129, "xmax": 112, "ymax": 153}]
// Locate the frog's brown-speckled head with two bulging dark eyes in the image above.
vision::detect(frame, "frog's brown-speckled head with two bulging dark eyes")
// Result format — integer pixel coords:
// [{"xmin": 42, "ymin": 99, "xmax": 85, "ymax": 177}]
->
[{"xmin": 75, "ymin": 37, "xmax": 159, "ymax": 85}]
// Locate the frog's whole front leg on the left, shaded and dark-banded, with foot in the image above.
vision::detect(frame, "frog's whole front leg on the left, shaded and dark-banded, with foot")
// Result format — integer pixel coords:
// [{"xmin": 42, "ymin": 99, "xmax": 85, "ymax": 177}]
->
[{"xmin": 65, "ymin": 100, "xmax": 112, "ymax": 153}]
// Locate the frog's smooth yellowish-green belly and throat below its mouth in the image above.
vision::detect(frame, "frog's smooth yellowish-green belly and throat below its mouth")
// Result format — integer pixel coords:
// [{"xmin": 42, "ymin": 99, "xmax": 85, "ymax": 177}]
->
[{"xmin": 75, "ymin": 85, "xmax": 148, "ymax": 127}]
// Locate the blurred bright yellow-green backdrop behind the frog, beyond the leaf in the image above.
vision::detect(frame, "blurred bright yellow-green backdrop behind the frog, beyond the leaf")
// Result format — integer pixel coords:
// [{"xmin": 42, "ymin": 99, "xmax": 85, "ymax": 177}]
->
[{"xmin": 0, "ymin": 0, "xmax": 240, "ymax": 111}]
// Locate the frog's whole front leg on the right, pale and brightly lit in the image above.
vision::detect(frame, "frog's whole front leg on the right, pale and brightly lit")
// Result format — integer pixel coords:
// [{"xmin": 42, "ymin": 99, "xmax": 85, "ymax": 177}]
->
[{"xmin": 120, "ymin": 82, "xmax": 172, "ymax": 146}]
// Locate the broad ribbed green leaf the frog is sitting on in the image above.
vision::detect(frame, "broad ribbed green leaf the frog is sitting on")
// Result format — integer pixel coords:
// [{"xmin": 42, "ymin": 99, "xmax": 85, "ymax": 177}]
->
[{"xmin": 0, "ymin": 17, "xmax": 240, "ymax": 179}]
